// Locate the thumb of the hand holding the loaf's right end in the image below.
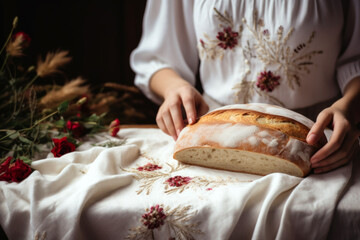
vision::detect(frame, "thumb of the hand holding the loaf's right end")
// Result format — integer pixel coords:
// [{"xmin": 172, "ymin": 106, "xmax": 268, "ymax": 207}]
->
[{"xmin": 306, "ymin": 110, "xmax": 333, "ymax": 145}]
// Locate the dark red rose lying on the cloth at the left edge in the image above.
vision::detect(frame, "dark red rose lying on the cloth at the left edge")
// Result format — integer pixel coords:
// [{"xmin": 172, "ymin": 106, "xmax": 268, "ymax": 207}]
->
[{"xmin": 0, "ymin": 157, "xmax": 32, "ymax": 182}]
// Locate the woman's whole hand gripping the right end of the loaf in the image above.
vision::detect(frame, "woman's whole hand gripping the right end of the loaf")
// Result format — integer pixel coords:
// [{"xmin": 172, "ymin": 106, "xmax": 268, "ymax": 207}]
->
[{"xmin": 306, "ymin": 104, "xmax": 360, "ymax": 173}]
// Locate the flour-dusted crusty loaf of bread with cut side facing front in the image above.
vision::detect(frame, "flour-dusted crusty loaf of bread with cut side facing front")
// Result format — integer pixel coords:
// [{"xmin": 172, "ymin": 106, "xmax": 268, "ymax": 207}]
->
[{"xmin": 173, "ymin": 103, "xmax": 320, "ymax": 177}]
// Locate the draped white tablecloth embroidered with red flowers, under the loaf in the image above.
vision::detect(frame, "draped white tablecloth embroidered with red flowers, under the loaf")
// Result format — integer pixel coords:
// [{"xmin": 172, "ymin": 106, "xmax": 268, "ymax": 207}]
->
[{"xmin": 0, "ymin": 128, "xmax": 357, "ymax": 239}]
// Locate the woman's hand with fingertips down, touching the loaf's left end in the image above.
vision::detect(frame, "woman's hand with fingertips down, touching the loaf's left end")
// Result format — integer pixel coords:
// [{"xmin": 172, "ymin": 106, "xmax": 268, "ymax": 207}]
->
[{"xmin": 156, "ymin": 82, "xmax": 209, "ymax": 140}]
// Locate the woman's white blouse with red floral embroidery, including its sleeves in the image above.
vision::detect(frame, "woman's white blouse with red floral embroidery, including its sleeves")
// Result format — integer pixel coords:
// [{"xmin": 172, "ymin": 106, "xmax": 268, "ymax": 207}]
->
[{"xmin": 130, "ymin": 0, "xmax": 360, "ymax": 109}]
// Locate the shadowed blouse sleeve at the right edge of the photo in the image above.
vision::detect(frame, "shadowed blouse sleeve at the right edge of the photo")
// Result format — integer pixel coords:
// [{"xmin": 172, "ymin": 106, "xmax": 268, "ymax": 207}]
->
[{"xmin": 337, "ymin": 0, "xmax": 360, "ymax": 93}]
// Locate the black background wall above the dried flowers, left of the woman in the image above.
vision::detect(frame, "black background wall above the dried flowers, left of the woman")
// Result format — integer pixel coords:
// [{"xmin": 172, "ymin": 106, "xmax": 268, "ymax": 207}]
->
[{"xmin": 0, "ymin": 0, "xmax": 146, "ymax": 85}]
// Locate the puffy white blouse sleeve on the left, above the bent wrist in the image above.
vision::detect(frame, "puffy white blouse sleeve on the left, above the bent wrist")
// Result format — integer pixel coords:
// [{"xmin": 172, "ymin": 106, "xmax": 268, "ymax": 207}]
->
[{"xmin": 130, "ymin": 0, "xmax": 198, "ymax": 104}]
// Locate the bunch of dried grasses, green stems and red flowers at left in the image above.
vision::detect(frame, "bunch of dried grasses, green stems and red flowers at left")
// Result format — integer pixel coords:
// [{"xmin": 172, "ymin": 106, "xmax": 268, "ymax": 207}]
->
[{"xmin": 0, "ymin": 17, "xmax": 142, "ymax": 182}]
